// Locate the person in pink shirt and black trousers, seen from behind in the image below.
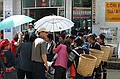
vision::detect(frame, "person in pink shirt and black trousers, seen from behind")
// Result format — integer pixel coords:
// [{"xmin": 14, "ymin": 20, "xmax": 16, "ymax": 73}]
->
[{"xmin": 53, "ymin": 40, "xmax": 69, "ymax": 79}]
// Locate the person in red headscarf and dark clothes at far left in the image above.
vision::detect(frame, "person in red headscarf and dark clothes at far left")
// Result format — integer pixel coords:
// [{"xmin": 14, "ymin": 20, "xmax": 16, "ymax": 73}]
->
[{"xmin": 0, "ymin": 39, "xmax": 18, "ymax": 79}]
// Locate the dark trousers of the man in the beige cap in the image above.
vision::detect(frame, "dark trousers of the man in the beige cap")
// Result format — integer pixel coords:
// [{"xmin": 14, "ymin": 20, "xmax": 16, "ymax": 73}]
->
[{"xmin": 32, "ymin": 61, "xmax": 45, "ymax": 79}]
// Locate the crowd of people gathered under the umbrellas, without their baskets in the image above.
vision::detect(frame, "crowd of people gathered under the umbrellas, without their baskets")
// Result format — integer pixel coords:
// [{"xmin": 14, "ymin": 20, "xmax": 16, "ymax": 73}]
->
[{"xmin": 0, "ymin": 24, "xmax": 107, "ymax": 79}]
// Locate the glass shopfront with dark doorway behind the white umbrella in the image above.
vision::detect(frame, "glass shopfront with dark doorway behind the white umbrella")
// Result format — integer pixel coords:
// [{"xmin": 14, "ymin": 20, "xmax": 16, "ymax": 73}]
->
[{"xmin": 22, "ymin": 0, "xmax": 92, "ymax": 30}]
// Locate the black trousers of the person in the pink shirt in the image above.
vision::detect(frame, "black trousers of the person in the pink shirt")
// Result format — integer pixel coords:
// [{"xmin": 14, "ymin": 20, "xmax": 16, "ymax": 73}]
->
[{"xmin": 54, "ymin": 66, "xmax": 66, "ymax": 79}]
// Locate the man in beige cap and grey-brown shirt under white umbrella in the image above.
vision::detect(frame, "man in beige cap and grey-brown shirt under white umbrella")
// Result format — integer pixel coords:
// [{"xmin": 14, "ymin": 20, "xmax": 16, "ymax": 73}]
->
[{"xmin": 31, "ymin": 28, "xmax": 48, "ymax": 79}]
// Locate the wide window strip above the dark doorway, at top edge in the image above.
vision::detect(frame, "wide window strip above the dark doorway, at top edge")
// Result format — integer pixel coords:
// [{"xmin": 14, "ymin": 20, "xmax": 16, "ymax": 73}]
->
[{"xmin": 23, "ymin": 0, "xmax": 65, "ymax": 8}]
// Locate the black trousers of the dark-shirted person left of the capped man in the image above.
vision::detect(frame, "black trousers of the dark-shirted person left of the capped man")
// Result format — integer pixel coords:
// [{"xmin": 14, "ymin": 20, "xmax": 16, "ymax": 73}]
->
[{"xmin": 17, "ymin": 69, "xmax": 33, "ymax": 79}]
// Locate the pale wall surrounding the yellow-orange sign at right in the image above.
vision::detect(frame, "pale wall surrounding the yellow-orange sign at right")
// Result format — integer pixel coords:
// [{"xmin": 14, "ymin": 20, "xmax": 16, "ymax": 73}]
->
[{"xmin": 92, "ymin": 0, "xmax": 120, "ymax": 42}]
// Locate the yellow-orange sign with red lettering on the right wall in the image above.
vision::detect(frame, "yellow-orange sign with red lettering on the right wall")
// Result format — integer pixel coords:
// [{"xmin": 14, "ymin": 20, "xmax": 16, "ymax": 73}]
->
[{"xmin": 106, "ymin": 2, "xmax": 120, "ymax": 22}]
